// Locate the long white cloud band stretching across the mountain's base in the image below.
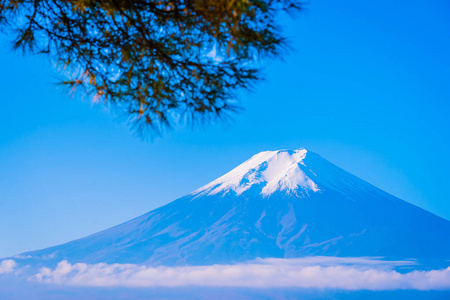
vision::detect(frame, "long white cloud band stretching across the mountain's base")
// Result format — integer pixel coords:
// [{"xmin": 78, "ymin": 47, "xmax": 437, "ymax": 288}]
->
[{"xmin": 32, "ymin": 257, "xmax": 450, "ymax": 290}]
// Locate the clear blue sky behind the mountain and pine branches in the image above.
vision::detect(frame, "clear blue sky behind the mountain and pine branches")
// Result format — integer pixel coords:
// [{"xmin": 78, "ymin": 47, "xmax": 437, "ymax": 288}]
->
[{"xmin": 0, "ymin": 0, "xmax": 450, "ymax": 257}]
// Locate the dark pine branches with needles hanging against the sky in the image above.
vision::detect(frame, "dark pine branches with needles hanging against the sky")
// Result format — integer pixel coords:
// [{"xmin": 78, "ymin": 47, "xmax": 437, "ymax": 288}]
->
[{"xmin": 0, "ymin": 0, "xmax": 300, "ymax": 132}]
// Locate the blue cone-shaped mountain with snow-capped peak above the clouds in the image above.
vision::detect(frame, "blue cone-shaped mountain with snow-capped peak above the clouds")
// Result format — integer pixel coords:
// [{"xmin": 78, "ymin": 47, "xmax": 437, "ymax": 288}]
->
[{"xmin": 14, "ymin": 148, "xmax": 450, "ymax": 265}]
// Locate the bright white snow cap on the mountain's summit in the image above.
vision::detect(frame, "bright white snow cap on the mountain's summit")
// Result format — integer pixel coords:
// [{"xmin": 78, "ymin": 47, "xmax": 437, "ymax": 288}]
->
[{"xmin": 192, "ymin": 148, "xmax": 320, "ymax": 196}]
